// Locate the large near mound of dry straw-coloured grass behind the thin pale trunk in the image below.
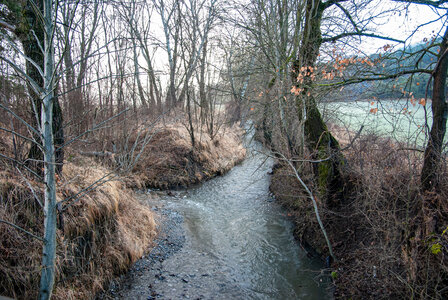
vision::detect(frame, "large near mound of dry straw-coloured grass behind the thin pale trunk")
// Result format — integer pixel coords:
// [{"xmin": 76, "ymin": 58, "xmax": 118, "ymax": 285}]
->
[{"xmin": 0, "ymin": 160, "xmax": 156, "ymax": 299}]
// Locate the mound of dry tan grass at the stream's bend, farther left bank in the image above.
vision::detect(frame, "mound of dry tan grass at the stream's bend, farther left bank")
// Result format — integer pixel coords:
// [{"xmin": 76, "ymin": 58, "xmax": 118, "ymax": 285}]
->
[{"xmin": 127, "ymin": 123, "xmax": 246, "ymax": 189}]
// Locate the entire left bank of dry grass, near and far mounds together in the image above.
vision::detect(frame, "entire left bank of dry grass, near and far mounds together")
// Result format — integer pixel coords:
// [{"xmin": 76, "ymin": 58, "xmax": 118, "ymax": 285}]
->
[{"xmin": 0, "ymin": 120, "xmax": 245, "ymax": 299}]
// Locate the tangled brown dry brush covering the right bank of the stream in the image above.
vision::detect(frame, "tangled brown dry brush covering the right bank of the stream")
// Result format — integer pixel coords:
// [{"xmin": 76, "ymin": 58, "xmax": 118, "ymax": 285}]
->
[{"xmin": 271, "ymin": 126, "xmax": 448, "ymax": 299}]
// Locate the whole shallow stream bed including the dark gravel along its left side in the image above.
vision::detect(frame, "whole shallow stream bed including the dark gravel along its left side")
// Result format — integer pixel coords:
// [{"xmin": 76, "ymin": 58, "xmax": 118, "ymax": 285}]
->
[{"xmin": 112, "ymin": 137, "xmax": 330, "ymax": 299}]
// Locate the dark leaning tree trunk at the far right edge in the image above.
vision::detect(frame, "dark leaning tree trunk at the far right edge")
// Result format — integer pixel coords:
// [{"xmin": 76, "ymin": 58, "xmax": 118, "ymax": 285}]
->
[{"xmin": 421, "ymin": 27, "xmax": 448, "ymax": 191}]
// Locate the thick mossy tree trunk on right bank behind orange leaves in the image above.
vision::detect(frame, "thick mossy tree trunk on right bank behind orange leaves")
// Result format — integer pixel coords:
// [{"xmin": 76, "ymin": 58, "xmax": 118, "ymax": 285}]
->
[{"xmin": 292, "ymin": 0, "xmax": 344, "ymax": 206}]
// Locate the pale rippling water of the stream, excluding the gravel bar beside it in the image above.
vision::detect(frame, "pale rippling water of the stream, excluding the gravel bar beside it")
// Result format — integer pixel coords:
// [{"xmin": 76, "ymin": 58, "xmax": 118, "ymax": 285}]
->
[{"xmin": 159, "ymin": 138, "xmax": 328, "ymax": 299}]
